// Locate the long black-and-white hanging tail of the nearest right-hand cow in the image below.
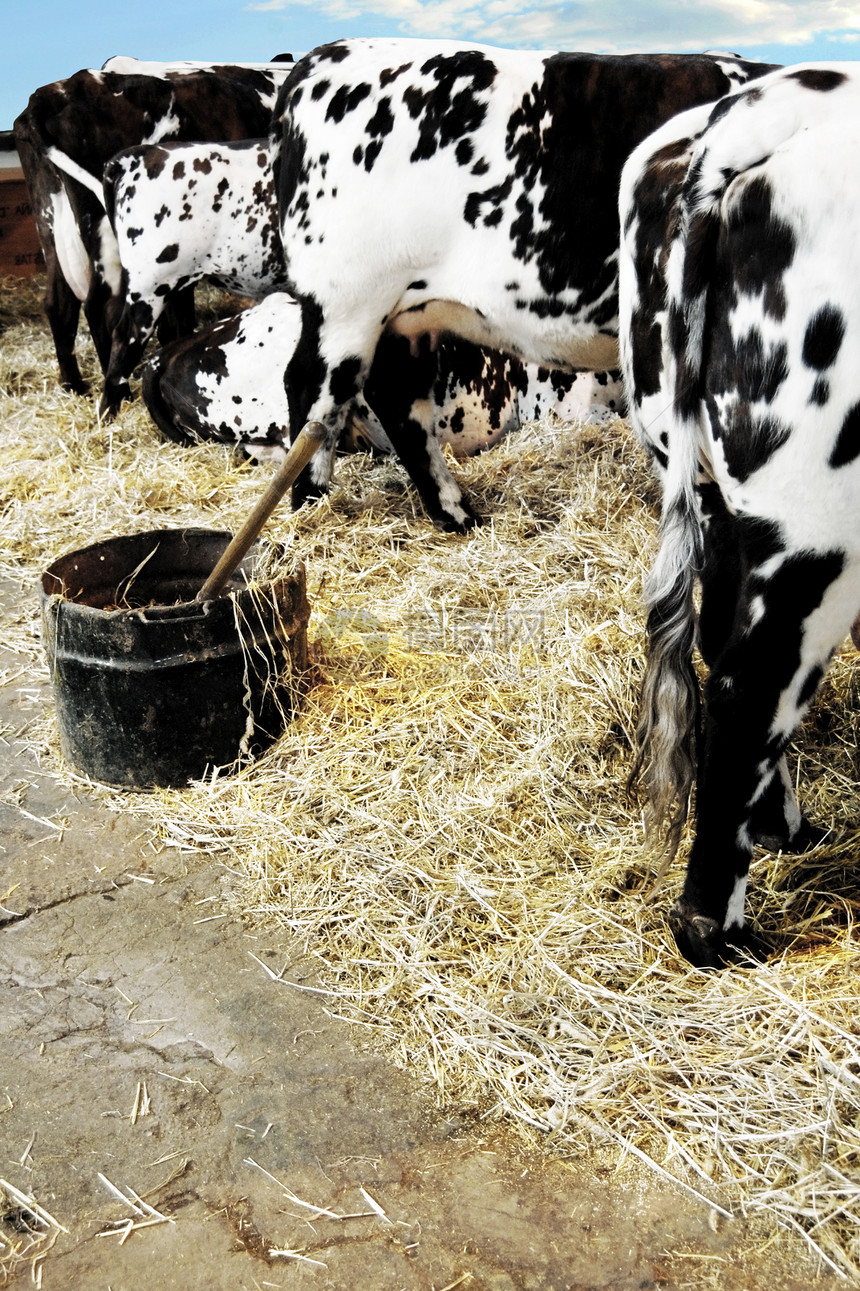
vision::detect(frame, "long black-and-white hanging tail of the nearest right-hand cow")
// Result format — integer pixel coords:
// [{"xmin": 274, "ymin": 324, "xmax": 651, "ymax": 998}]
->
[{"xmin": 630, "ymin": 164, "xmax": 719, "ymax": 868}]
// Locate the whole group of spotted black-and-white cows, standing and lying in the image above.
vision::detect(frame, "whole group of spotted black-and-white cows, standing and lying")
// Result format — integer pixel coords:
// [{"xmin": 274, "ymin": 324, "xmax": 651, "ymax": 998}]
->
[{"xmin": 14, "ymin": 39, "xmax": 860, "ymax": 967}]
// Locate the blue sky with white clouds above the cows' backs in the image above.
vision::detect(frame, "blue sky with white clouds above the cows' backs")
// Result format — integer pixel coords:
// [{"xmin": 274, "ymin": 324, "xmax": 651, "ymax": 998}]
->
[{"xmin": 0, "ymin": 0, "xmax": 860, "ymax": 129}]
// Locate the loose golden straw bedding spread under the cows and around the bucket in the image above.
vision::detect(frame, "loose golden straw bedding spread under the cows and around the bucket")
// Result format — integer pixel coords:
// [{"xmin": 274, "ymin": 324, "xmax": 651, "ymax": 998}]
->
[{"xmin": 0, "ymin": 277, "xmax": 860, "ymax": 1277}]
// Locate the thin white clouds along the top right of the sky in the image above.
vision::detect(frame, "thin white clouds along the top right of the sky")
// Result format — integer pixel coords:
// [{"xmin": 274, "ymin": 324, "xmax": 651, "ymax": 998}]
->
[{"xmin": 249, "ymin": 0, "xmax": 860, "ymax": 53}]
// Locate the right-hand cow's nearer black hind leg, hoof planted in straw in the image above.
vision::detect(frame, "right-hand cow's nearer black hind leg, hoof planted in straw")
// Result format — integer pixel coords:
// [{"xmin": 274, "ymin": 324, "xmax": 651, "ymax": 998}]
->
[{"xmin": 671, "ymin": 539, "xmax": 860, "ymax": 968}]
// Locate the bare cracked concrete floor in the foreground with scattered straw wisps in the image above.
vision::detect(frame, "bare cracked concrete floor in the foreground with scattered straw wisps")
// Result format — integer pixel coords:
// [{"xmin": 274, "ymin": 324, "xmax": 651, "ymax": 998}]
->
[{"xmin": 0, "ymin": 580, "xmax": 837, "ymax": 1291}]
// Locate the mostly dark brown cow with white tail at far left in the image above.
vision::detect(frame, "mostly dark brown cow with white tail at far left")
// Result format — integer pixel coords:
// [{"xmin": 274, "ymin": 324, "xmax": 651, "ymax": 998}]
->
[{"xmin": 13, "ymin": 58, "xmax": 292, "ymax": 392}]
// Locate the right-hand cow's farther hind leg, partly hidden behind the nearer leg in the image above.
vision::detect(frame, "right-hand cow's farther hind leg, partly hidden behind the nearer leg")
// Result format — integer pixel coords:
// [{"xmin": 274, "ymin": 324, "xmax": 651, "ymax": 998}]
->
[{"xmin": 699, "ymin": 484, "xmax": 826, "ymax": 852}]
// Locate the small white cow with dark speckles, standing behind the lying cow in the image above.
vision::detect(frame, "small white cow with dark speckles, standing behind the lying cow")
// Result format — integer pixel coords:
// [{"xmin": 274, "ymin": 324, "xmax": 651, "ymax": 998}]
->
[{"xmin": 101, "ymin": 139, "xmax": 285, "ymax": 416}]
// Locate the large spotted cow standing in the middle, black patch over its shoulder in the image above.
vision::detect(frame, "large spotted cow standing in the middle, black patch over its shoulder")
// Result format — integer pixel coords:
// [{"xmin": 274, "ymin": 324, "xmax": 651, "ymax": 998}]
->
[{"xmin": 272, "ymin": 39, "xmax": 768, "ymax": 529}]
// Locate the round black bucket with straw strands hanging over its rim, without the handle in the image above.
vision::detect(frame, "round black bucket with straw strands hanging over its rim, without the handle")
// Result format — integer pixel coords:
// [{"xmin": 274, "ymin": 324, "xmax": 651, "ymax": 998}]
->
[{"xmin": 40, "ymin": 529, "xmax": 310, "ymax": 789}]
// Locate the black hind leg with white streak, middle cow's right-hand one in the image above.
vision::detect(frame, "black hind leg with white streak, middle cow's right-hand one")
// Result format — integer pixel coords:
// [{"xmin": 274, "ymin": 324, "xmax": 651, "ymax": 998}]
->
[{"xmin": 364, "ymin": 334, "xmax": 479, "ymax": 533}]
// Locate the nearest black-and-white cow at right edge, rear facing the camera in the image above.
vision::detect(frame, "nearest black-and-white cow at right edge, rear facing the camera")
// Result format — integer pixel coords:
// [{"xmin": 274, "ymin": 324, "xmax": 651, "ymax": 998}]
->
[{"xmin": 620, "ymin": 63, "xmax": 860, "ymax": 967}]
